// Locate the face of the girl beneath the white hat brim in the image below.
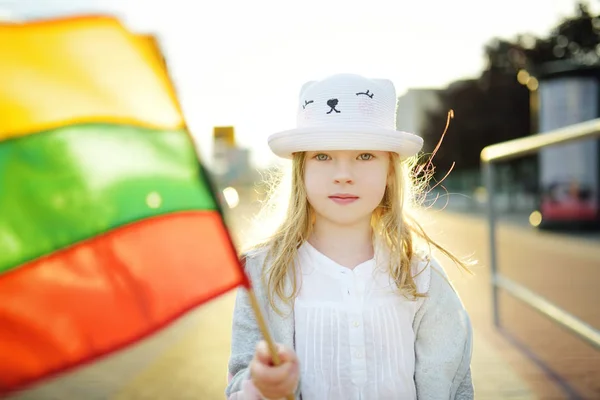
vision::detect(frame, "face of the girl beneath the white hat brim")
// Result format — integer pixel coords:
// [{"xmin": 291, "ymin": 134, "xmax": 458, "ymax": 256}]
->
[{"xmin": 304, "ymin": 150, "xmax": 390, "ymax": 225}]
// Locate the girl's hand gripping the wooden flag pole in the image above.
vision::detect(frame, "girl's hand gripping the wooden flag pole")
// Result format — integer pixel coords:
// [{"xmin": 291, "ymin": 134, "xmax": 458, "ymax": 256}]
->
[{"xmin": 250, "ymin": 341, "xmax": 300, "ymax": 399}]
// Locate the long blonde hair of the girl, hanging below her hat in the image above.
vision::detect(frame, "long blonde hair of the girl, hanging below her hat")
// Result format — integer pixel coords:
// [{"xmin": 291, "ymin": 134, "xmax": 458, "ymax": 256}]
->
[{"xmin": 246, "ymin": 152, "xmax": 470, "ymax": 313}]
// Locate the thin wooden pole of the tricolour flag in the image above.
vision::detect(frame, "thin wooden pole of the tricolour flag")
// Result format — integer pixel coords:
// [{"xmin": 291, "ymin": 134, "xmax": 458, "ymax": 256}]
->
[{"xmin": 155, "ymin": 36, "xmax": 295, "ymax": 400}]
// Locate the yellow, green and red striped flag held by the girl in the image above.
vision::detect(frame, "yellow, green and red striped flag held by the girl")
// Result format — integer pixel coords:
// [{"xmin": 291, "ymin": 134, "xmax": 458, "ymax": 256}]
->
[{"xmin": 0, "ymin": 16, "xmax": 248, "ymax": 398}]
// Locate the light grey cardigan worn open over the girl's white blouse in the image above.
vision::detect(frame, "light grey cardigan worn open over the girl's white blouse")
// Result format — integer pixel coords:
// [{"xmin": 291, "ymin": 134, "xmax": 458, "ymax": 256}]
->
[{"xmin": 225, "ymin": 250, "xmax": 474, "ymax": 400}]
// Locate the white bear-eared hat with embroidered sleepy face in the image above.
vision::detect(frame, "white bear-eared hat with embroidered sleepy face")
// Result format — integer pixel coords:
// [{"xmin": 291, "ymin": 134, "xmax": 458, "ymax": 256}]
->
[{"xmin": 268, "ymin": 74, "xmax": 423, "ymax": 158}]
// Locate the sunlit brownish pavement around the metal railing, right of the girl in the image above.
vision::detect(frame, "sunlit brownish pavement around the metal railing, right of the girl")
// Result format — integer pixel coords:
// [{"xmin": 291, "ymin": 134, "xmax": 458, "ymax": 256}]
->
[{"xmin": 428, "ymin": 210, "xmax": 600, "ymax": 399}]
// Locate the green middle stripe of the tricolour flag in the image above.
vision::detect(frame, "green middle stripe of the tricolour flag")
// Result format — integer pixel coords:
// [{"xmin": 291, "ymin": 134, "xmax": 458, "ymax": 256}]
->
[{"xmin": 0, "ymin": 124, "xmax": 216, "ymax": 273}]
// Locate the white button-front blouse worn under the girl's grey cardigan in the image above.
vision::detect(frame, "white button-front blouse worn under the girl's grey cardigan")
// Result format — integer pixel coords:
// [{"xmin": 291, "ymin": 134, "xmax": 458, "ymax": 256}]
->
[{"xmin": 294, "ymin": 242, "xmax": 417, "ymax": 400}]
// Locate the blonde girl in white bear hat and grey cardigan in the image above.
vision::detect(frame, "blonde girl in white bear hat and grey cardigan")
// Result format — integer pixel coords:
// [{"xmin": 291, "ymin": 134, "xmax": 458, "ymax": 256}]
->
[{"xmin": 226, "ymin": 74, "xmax": 473, "ymax": 400}]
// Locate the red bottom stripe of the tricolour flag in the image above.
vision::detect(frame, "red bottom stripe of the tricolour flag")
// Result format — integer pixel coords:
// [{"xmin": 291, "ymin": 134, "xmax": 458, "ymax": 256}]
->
[{"xmin": 0, "ymin": 211, "xmax": 248, "ymax": 393}]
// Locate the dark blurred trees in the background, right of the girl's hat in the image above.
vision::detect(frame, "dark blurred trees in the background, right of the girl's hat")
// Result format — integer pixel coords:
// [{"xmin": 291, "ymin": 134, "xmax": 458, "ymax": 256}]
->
[{"xmin": 423, "ymin": 2, "xmax": 600, "ymax": 178}]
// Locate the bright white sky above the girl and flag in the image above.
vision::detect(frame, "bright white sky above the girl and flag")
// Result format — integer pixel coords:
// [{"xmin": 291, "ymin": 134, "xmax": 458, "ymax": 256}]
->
[{"xmin": 0, "ymin": 0, "xmax": 600, "ymax": 166}]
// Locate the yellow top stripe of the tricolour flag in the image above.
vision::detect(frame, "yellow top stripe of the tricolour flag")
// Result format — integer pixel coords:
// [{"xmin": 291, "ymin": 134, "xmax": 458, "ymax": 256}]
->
[{"xmin": 0, "ymin": 16, "xmax": 184, "ymax": 141}]
